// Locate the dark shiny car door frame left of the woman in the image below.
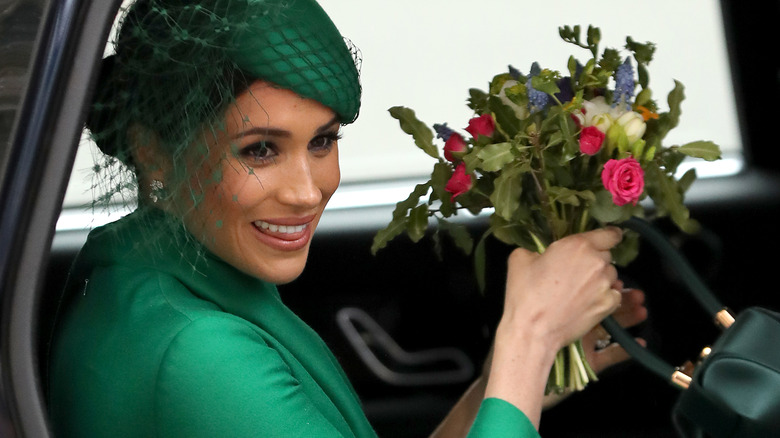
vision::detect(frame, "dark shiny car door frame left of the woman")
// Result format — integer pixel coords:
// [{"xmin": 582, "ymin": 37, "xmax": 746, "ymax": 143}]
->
[{"xmin": 0, "ymin": 0, "xmax": 121, "ymax": 438}]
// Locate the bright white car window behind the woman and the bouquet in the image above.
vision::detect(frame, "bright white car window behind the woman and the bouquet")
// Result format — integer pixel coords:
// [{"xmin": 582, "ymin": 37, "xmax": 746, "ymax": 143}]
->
[{"xmin": 58, "ymin": 0, "xmax": 741, "ymax": 215}]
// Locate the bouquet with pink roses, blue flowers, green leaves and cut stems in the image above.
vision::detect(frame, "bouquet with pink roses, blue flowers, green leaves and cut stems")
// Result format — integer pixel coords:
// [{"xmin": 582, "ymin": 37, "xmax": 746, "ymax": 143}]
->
[{"xmin": 372, "ymin": 26, "xmax": 720, "ymax": 392}]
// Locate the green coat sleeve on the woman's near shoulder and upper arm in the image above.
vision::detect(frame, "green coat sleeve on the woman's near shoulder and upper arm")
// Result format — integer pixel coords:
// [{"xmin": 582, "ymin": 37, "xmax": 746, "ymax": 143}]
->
[{"xmin": 150, "ymin": 317, "xmax": 343, "ymax": 438}]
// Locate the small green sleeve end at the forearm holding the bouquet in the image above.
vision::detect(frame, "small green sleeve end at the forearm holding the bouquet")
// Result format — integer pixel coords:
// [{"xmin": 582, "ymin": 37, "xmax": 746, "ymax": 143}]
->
[{"xmin": 468, "ymin": 398, "xmax": 539, "ymax": 438}]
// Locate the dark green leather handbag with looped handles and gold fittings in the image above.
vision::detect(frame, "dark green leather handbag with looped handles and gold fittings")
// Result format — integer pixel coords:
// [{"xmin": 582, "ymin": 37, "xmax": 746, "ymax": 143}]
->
[{"xmin": 603, "ymin": 218, "xmax": 780, "ymax": 438}]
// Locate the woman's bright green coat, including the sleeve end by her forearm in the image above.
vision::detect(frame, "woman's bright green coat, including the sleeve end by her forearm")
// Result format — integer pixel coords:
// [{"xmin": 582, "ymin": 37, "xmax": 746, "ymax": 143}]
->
[{"xmin": 49, "ymin": 211, "xmax": 536, "ymax": 438}]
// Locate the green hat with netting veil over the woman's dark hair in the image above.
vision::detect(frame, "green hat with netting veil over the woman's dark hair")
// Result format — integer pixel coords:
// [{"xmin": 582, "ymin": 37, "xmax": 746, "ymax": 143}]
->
[{"xmin": 87, "ymin": 0, "xmax": 361, "ymax": 270}]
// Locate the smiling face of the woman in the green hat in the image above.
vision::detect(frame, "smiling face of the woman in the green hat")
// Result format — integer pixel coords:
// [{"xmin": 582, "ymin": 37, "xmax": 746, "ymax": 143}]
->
[{"xmin": 184, "ymin": 81, "xmax": 340, "ymax": 284}]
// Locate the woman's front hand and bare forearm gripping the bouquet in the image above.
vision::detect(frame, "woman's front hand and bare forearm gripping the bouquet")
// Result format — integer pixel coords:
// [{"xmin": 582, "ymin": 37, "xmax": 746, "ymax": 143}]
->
[{"xmin": 485, "ymin": 228, "xmax": 623, "ymax": 425}]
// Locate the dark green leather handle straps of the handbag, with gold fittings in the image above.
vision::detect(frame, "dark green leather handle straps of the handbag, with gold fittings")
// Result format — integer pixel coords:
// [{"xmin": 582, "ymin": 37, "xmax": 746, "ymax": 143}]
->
[{"xmin": 602, "ymin": 217, "xmax": 734, "ymax": 388}]
